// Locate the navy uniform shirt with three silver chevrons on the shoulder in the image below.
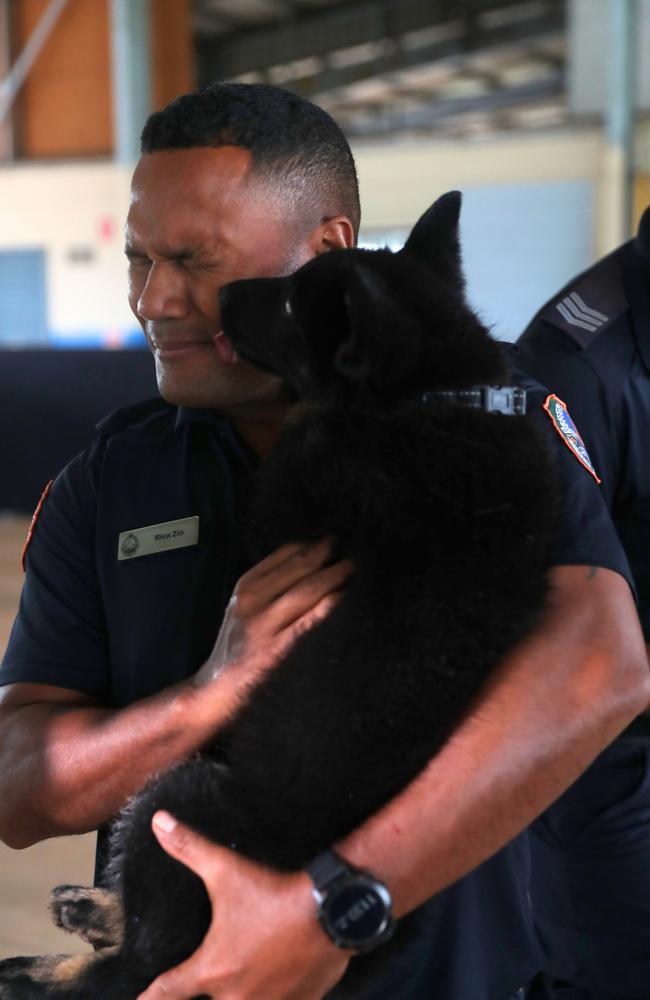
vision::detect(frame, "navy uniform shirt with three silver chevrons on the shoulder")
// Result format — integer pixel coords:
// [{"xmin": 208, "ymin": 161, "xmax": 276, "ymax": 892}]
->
[{"xmin": 519, "ymin": 208, "xmax": 650, "ymax": 733}]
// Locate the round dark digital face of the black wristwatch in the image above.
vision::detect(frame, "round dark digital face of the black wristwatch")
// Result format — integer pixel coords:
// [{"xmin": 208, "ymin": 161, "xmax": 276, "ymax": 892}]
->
[{"xmin": 326, "ymin": 878, "xmax": 390, "ymax": 947}]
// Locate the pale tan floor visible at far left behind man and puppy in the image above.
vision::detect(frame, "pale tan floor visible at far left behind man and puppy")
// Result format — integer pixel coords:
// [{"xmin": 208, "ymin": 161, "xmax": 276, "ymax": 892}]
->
[{"xmin": 0, "ymin": 516, "xmax": 95, "ymax": 959}]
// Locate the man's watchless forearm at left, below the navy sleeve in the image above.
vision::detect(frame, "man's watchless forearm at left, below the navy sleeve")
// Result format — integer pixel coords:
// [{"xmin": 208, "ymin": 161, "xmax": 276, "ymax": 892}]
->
[{"xmin": 0, "ymin": 679, "xmax": 240, "ymax": 848}]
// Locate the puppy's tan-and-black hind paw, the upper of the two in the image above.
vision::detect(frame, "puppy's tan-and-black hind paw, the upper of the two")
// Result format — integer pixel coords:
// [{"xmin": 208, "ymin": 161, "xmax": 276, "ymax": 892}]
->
[{"xmin": 50, "ymin": 885, "xmax": 124, "ymax": 949}]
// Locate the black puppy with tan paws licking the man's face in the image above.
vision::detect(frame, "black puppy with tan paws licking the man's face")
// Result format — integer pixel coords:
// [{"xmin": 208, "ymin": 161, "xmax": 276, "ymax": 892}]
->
[{"xmin": 0, "ymin": 193, "xmax": 555, "ymax": 1000}]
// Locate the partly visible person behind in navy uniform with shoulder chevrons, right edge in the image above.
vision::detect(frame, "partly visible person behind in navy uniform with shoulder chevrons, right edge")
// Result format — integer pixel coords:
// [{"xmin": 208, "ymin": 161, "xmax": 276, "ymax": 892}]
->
[{"xmin": 519, "ymin": 208, "xmax": 650, "ymax": 1000}]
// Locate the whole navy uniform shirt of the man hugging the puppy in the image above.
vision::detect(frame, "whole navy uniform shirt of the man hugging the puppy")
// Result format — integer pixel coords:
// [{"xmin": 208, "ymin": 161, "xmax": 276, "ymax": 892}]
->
[{"xmin": 0, "ymin": 360, "xmax": 628, "ymax": 1000}]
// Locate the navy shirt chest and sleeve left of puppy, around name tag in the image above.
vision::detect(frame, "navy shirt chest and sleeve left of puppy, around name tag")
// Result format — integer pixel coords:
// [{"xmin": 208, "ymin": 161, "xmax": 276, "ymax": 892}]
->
[{"xmin": 0, "ymin": 400, "xmax": 253, "ymax": 708}]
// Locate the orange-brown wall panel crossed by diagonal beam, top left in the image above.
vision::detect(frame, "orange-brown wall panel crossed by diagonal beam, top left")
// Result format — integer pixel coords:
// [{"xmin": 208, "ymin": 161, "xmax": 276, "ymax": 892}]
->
[{"xmin": 12, "ymin": 0, "xmax": 112, "ymax": 158}]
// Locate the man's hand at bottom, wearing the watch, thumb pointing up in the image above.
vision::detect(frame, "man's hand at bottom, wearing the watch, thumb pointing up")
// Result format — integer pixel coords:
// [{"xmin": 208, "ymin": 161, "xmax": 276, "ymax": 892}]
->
[{"xmin": 139, "ymin": 813, "xmax": 349, "ymax": 1000}]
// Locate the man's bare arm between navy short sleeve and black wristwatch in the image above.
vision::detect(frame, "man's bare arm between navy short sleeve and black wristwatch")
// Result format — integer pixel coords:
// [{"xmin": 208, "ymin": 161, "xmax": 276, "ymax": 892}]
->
[{"xmin": 339, "ymin": 567, "xmax": 650, "ymax": 914}]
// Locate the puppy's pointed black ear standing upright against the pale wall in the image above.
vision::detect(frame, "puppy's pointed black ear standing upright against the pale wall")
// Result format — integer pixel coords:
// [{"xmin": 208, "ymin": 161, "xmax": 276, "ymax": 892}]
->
[{"xmin": 400, "ymin": 191, "xmax": 465, "ymax": 294}]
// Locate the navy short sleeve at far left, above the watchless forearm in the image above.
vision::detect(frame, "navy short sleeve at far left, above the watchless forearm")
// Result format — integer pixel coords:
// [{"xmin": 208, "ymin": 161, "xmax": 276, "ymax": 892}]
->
[{"xmin": 0, "ymin": 453, "xmax": 109, "ymax": 700}]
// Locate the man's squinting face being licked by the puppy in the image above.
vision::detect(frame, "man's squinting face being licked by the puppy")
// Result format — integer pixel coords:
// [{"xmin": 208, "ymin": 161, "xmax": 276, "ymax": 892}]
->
[{"xmin": 126, "ymin": 146, "xmax": 312, "ymax": 416}]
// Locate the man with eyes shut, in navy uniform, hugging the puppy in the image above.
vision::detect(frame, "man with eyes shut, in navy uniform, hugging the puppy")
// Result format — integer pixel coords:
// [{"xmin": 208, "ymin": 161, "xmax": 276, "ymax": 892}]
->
[{"xmin": 0, "ymin": 85, "xmax": 650, "ymax": 1000}]
